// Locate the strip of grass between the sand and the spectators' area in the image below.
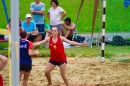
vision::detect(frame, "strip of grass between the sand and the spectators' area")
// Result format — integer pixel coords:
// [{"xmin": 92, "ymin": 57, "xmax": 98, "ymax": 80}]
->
[{"xmin": 0, "ymin": 42, "xmax": 130, "ymax": 61}]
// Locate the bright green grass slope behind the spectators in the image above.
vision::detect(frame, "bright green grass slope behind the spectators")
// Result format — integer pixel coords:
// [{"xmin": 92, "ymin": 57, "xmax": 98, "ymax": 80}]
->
[{"xmin": 0, "ymin": 0, "xmax": 130, "ymax": 33}]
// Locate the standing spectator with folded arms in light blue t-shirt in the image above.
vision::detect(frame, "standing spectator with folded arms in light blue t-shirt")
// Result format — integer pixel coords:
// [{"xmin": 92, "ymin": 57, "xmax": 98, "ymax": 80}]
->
[{"xmin": 30, "ymin": 0, "xmax": 45, "ymax": 41}]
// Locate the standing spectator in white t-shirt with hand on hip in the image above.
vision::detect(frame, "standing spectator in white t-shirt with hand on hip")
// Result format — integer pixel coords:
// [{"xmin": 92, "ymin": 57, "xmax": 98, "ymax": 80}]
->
[{"xmin": 47, "ymin": 0, "xmax": 66, "ymax": 35}]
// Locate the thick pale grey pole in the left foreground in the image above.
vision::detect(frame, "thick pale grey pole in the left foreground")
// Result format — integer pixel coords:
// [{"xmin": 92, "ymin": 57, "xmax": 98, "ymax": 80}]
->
[{"xmin": 10, "ymin": 0, "xmax": 19, "ymax": 86}]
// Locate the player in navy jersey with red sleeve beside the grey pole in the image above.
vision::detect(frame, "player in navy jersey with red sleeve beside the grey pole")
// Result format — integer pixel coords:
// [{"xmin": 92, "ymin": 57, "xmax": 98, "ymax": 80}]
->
[{"xmin": 20, "ymin": 31, "xmax": 38, "ymax": 86}]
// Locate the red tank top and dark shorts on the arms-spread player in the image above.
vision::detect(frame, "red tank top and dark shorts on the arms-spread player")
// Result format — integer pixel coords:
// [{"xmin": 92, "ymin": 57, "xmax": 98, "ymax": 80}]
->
[{"xmin": 49, "ymin": 36, "xmax": 67, "ymax": 66}]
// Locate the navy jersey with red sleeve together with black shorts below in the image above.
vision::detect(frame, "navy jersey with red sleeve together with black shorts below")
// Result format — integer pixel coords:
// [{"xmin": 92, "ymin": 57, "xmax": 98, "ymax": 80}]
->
[{"xmin": 20, "ymin": 39, "xmax": 33, "ymax": 72}]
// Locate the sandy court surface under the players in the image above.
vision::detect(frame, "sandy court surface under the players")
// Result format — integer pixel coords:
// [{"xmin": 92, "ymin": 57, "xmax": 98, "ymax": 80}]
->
[{"xmin": 0, "ymin": 57, "xmax": 130, "ymax": 86}]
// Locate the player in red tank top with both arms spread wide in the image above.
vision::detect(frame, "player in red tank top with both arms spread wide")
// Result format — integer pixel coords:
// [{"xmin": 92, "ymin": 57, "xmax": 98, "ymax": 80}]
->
[{"xmin": 33, "ymin": 27, "xmax": 87, "ymax": 86}]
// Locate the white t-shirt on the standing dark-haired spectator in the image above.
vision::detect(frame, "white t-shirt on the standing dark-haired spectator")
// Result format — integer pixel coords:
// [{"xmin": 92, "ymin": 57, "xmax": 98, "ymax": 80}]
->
[{"xmin": 48, "ymin": 7, "xmax": 64, "ymax": 25}]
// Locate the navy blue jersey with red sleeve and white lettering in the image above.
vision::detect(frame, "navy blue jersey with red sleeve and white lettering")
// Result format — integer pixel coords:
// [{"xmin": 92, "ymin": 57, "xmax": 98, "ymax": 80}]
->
[{"xmin": 20, "ymin": 39, "xmax": 32, "ymax": 65}]
